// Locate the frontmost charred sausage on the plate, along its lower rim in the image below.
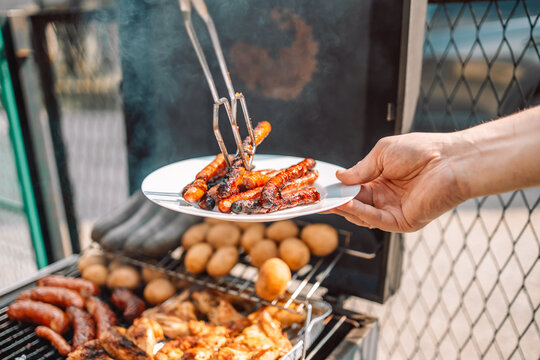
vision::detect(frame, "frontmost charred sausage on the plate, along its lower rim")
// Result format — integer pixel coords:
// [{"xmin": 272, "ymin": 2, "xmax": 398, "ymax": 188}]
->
[{"xmin": 231, "ymin": 187, "xmax": 321, "ymax": 214}]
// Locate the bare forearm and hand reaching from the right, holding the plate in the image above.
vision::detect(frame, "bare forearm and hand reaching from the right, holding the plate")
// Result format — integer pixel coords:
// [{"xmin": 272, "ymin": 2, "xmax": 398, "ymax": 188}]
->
[{"xmin": 326, "ymin": 106, "xmax": 540, "ymax": 232}]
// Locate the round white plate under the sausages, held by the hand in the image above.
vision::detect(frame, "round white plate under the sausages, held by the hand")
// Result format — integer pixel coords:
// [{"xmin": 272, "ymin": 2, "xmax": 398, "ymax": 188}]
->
[{"xmin": 142, "ymin": 154, "xmax": 360, "ymax": 222}]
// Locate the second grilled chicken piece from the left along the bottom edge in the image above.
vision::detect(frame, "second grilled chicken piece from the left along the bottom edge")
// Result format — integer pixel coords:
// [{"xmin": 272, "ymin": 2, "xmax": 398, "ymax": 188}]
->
[{"xmin": 99, "ymin": 327, "xmax": 152, "ymax": 360}]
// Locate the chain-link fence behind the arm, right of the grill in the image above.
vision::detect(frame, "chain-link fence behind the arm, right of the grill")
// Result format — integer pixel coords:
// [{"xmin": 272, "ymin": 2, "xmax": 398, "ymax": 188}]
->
[{"xmin": 348, "ymin": 1, "xmax": 540, "ymax": 359}]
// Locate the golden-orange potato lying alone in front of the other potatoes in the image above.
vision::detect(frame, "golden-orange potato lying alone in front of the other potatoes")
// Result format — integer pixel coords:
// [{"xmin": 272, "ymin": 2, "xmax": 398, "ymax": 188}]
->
[{"xmin": 255, "ymin": 258, "xmax": 291, "ymax": 301}]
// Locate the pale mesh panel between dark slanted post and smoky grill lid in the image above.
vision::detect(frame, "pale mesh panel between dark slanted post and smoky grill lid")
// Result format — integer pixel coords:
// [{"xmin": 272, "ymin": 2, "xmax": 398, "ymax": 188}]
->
[{"xmin": 46, "ymin": 12, "xmax": 128, "ymax": 231}]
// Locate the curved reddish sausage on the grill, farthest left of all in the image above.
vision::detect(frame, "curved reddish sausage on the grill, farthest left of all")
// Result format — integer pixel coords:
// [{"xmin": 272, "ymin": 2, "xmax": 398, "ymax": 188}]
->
[{"xmin": 7, "ymin": 300, "xmax": 69, "ymax": 334}]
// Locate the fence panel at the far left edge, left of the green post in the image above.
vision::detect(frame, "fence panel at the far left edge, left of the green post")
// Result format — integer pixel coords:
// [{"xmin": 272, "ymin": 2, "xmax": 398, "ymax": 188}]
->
[{"xmin": 0, "ymin": 106, "xmax": 37, "ymax": 288}]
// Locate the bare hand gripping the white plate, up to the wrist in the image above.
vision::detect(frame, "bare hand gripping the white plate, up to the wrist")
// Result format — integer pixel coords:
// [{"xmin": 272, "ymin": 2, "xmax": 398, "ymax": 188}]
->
[{"xmin": 330, "ymin": 133, "xmax": 467, "ymax": 232}]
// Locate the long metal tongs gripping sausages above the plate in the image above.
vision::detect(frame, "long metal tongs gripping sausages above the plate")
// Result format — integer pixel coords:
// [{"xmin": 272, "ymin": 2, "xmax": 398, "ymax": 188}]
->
[{"xmin": 179, "ymin": 0, "xmax": 257, "ymax": 170}]
